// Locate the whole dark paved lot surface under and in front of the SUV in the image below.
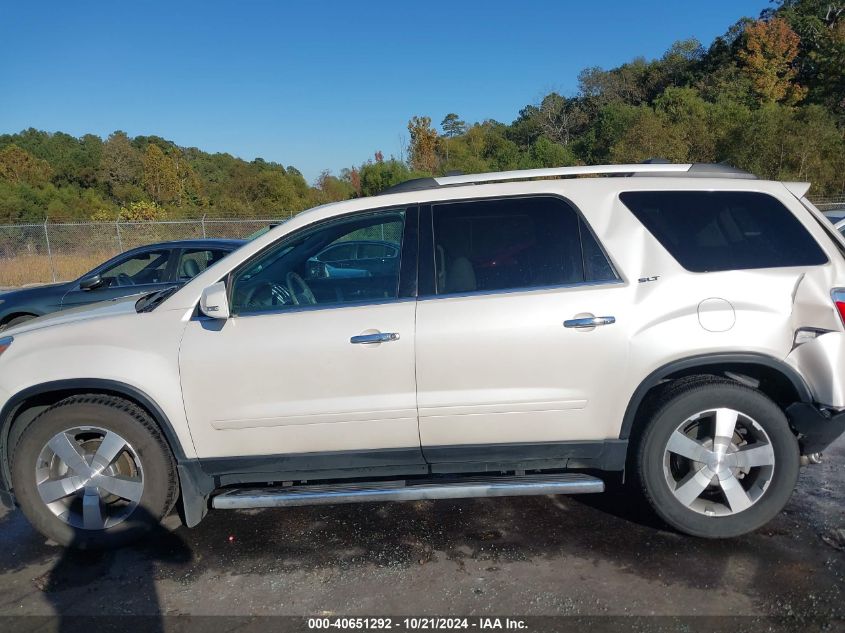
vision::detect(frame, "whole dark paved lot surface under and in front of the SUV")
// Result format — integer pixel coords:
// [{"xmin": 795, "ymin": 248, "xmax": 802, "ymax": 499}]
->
[{"xmin": 0, "ymin": 441, "xmax": 845, "ymax": 630}]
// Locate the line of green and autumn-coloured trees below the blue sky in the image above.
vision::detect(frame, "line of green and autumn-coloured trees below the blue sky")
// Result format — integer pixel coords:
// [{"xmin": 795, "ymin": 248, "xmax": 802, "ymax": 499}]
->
[{"xmin": 0, "ymin": 0, "xmax": 845, "ymax": 223}]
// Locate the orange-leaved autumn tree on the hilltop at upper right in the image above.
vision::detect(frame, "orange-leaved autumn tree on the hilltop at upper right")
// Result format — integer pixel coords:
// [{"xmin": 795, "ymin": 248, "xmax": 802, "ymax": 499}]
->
[{"xmin": 739, "ymin": 18, "xmax": 806, "ymax": 105}]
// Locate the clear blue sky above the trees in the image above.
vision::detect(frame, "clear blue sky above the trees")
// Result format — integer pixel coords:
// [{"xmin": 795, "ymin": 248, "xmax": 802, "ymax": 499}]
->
[{"xmin": 0, "ymin": 0, "xmax": 769, "ymax": 180}]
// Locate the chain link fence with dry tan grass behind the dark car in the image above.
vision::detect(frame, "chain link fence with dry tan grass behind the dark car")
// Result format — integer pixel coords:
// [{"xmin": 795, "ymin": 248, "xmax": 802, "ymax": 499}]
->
[{"xmin": 0, "ymin": 218, "xmax": 280, "ymax": 288}]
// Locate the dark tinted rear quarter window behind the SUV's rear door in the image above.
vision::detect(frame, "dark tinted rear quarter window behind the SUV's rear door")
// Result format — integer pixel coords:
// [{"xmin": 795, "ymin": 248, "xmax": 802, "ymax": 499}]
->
[{"xmin": 619, "ymin": 191, "xmax": 828, "ymax": 273}]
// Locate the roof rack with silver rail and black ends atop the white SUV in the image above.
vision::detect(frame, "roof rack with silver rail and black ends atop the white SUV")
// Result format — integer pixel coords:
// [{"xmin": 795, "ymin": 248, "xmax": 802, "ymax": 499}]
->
[{"xmin": 381, "ymin": 159, "xmax": 756, "ymax": 194}]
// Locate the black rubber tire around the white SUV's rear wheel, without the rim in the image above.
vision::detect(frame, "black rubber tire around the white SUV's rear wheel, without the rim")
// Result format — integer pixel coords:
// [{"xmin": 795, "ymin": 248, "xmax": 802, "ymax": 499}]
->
[{"xmin": 636, "ymin": 379, "xmax": 800, "ymax": 538}]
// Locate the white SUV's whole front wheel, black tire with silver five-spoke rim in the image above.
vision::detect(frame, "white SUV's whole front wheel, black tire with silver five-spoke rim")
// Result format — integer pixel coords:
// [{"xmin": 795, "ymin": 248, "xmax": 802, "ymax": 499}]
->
[{"xmin": 12, "ymin": 394, "xmax": 178, "ymax": 549}]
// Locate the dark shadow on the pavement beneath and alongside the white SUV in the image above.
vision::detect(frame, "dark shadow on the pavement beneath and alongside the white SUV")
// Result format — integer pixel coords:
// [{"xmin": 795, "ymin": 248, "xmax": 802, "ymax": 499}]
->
[{"xmin": 0, "ymin": 442, "xmax": 845, "ymax": 617}]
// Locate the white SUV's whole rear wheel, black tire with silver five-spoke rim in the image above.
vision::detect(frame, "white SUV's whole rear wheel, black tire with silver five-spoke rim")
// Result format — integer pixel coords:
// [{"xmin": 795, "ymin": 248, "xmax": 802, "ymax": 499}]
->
[{"xmin": 636, "ymin": 379, "xmax": 800, "ymax": 538}]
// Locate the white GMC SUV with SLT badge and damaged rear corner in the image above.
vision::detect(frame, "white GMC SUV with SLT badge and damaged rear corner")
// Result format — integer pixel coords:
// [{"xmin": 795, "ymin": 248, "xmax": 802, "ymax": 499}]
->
[{"xmin": 0, "ymin": 164, "xmax": 845, "ymax": 547}]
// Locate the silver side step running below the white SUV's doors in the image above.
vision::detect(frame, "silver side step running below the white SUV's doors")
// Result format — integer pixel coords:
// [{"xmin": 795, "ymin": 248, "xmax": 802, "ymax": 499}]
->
[{"xmin": 211, "ymin": 473, "xmax": 604, "ymax": 510}]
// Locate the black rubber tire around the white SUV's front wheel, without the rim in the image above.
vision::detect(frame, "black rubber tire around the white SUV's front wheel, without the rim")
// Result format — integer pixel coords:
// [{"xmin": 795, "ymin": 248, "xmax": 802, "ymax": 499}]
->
[{"xmin": 12, "ymin": 394, "xmax": 178, "ymax": 549}]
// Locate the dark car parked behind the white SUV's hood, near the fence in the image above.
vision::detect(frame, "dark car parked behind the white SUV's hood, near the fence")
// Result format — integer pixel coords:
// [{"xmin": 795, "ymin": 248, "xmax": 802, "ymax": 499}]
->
[{"xmin": 0, "ymin": 239, "xmax": 245, "ymax": 330}]
